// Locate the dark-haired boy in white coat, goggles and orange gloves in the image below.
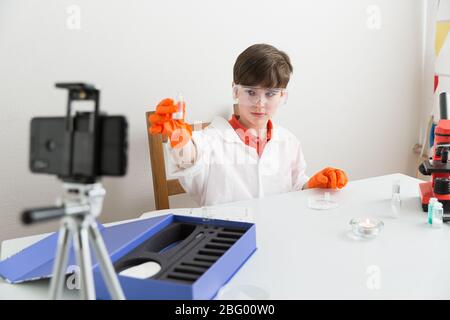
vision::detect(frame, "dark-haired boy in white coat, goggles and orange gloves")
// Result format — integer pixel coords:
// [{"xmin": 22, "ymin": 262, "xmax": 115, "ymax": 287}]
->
[{"xmin": 150, "ymin": 44, "xmax": 347, "ymax": 206}]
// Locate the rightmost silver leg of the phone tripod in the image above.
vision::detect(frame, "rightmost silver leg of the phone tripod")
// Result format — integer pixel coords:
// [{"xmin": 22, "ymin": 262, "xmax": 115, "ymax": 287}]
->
[{"xmin": 89, "ymin": 221, "xmax": 125, "ymax": 300}]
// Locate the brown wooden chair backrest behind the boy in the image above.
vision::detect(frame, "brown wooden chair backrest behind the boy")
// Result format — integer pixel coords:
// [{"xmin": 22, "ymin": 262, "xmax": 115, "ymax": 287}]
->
[{"xmin": 145, "ymin": 111, "xmax": 209, "ymax": 210}]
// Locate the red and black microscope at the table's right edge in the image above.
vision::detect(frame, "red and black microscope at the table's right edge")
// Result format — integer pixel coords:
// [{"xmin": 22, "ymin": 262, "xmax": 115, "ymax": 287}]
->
[{"xmin": 419, "ymin": 92, "xmax": 450, "ymax": 222}]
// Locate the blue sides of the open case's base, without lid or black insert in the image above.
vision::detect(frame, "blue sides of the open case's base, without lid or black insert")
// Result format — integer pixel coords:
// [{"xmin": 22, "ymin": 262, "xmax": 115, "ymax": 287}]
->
[{"xmin": 94, "ymin": 215, "xmax": 256, "ymax": 300}]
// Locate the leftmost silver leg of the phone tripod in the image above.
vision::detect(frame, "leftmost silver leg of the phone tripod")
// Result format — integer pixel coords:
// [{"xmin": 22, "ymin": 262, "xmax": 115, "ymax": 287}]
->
[{"xmin": 50, "ymin": 220, "xmax": 71, "ymax": 300}]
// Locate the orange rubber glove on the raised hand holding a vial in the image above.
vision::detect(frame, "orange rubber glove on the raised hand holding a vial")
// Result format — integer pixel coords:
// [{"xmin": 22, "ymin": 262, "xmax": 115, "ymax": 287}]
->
[{"xmin": 149, "ymin": 98, "xmax": 192, "ymax": 148}]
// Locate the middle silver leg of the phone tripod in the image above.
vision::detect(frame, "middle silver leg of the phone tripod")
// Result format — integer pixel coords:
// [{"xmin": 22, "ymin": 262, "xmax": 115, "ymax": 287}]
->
[{"xmin": 73, "ymin": 220, "xmax": 95, "ymax": 300}]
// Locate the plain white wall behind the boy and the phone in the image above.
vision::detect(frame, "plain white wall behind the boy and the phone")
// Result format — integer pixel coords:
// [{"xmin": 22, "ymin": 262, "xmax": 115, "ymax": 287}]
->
[{"xmin": 0, "ymin": 0, "xmax": 424, "ymax": 240}]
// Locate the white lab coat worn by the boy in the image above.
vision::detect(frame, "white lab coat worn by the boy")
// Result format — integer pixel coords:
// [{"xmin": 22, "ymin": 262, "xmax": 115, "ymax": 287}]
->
[{"xmin": 167, "ymin": 117, "xmax": 309, "ymax": 206}]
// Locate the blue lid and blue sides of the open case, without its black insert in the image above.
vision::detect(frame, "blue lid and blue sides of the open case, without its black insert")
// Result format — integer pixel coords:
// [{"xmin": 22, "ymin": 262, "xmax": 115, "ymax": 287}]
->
[{"xmin": 0, "ymin": 214, "xmax": 256, "ymax": 300}]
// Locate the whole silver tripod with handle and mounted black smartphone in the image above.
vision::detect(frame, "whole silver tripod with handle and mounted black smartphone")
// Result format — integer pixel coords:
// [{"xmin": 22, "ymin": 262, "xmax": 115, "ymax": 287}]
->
[{"xmin": 22, "ymin": 82, "xmax": 128, "ymax": 299}]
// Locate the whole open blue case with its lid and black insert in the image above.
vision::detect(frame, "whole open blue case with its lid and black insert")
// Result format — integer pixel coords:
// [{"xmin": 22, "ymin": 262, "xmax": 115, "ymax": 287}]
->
[{"xmin": 0, "ymin": 214, "xmax": 256, "ymax": 299}]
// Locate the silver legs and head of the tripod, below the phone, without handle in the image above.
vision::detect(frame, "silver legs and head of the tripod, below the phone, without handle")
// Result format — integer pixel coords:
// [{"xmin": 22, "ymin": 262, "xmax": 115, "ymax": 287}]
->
[{"xmin": 50, "ymin": 183, "xmax": 125, "ymax": 300}]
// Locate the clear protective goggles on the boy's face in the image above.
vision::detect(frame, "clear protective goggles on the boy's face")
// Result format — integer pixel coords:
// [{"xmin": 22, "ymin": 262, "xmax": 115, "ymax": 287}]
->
[{"xmin": 233, "ymin": 84, "xmax": 287, "ymax": 107}]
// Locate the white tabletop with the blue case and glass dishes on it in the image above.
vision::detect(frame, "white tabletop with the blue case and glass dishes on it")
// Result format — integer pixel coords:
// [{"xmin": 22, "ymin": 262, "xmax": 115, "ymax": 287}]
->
[{"xmin": 0, "ymin": 174, "xmax": 450, "ymax": 299}]
